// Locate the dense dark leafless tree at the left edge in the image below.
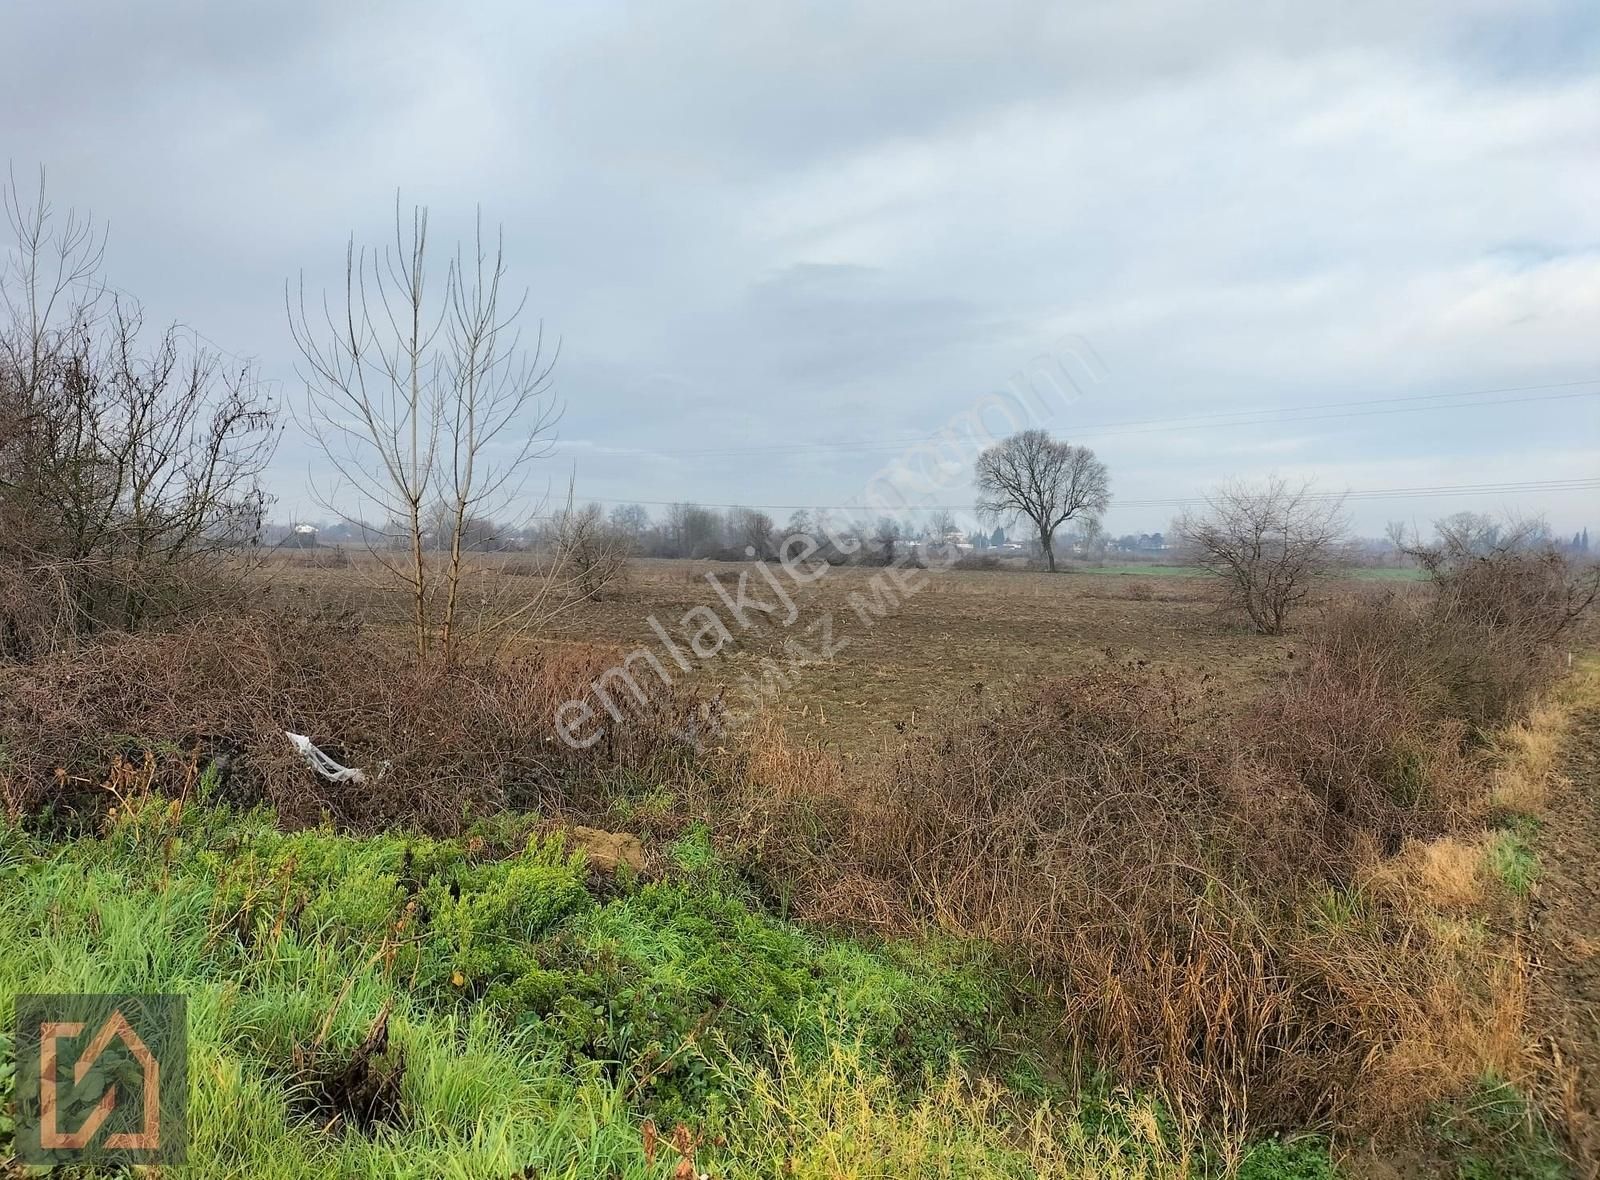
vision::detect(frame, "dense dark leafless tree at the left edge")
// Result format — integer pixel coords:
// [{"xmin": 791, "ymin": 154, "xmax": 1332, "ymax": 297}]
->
[{"xmin": 0, "ymin": 167, "xmax": 278, "ymax": 646}]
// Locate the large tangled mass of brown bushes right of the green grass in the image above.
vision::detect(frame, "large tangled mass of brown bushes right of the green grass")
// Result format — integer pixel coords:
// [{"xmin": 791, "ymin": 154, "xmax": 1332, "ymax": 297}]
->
[{"xmin": 729, "ymin": 566, "xmax": 1587, "ymax": 1129}]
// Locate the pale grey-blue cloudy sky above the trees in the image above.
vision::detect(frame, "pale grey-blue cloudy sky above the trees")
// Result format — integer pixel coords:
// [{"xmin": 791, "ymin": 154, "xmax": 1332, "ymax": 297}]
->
[{"xmin": 9, "ymin": 0, "xmax": 1600, "ymax": 532}]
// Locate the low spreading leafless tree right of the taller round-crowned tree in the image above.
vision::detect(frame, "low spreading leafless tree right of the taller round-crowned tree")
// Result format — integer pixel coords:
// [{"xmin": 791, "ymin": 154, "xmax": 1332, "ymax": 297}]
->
[{"xmin": 1176, "ymin": 476, "xmax": 1346, "ymax": 635}]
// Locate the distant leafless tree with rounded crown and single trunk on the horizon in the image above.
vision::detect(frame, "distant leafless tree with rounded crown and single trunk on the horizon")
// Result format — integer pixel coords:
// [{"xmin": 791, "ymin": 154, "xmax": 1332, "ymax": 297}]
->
[{"xmin": 978, "ymin": 430, "xmax": 1110, "ymax": 572}]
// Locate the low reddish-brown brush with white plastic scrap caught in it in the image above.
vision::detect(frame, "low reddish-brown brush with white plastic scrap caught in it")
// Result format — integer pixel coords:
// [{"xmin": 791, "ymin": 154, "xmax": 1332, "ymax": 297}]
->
[{"xmin": 0, "ymin": 617, "xmax": 707, "ymax": 831}]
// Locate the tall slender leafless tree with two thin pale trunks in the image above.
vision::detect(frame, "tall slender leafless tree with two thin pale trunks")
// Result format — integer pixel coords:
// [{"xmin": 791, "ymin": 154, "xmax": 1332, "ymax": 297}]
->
[{"xmin": 286, "ymin": 200, "xmax": 558, "ymax": 660}]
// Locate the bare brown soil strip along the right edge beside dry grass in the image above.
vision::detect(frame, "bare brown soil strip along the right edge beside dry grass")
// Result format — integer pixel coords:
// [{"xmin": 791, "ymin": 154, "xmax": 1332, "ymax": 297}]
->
[{"xmin": 1531, "ymin": 681, "xmax": 1600, "ymax": 1180}]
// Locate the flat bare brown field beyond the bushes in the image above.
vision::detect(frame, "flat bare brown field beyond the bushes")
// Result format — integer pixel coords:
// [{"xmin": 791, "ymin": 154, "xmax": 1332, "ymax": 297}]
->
[{"xmin": 261, "ymin": 560, "xmax": 1360, "ymax": 753}]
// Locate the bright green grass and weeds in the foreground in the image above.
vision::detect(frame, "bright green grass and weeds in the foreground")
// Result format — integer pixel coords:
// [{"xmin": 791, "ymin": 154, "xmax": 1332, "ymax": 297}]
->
[{"xmin": 0, "ymin": 799, "xmax": 1235, "ymax": 1178}]
